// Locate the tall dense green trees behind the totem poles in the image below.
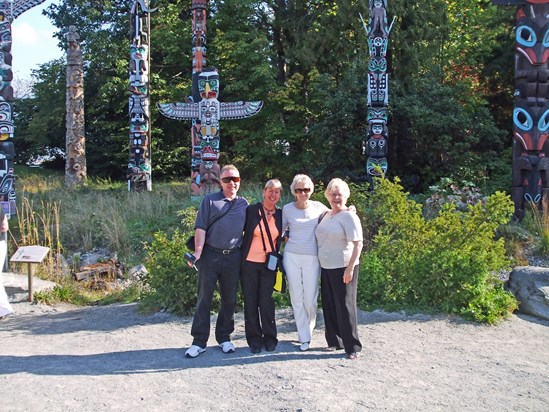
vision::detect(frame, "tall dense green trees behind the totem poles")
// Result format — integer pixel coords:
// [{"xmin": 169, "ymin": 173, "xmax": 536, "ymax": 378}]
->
[{"xmin": 8, "ymin": 0, "xmax": 514, "ymax": 189}]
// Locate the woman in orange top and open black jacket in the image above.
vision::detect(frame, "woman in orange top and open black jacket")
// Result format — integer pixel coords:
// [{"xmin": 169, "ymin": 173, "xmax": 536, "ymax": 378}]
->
[{"xmin": 240, "ymin": 179, "xmax": 282, "ymax": 353}]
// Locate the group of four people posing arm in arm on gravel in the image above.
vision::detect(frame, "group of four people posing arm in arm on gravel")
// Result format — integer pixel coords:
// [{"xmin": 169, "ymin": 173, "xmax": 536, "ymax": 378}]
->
[{"xmin": 185, "ymin": 165, "xmax": 362, "ymax": 359}]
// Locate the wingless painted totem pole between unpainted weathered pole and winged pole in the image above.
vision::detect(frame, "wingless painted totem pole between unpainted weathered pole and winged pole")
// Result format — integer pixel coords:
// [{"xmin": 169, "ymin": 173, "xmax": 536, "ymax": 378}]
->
[{"xmin": 127, "ymin": 0, "xmax": 156, "ymax": 192}]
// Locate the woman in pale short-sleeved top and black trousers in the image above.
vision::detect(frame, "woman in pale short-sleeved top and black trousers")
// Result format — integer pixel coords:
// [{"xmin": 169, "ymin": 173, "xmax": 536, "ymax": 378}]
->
[{"xmin": 315, "ymin": 179, "xmax": 362, "ymax": 359}]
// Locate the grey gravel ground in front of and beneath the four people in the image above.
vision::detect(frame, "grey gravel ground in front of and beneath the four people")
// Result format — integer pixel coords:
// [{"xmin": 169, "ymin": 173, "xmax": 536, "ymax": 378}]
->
[{"xmin": 0, "ymin": 272, "xmax": 549, "ymax": 412}]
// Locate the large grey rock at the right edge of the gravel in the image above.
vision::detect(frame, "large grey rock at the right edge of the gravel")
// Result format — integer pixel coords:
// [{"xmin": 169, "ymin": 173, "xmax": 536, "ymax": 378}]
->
[{"xmin": 506, "ymin": 266, "xmax": 549, "ymax": 320}]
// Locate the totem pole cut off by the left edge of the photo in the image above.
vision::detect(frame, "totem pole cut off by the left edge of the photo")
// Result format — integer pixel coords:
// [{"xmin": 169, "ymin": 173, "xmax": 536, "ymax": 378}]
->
[{"xmin": 0, "ymin": 0, "xmax": 44, "ymax": 215}]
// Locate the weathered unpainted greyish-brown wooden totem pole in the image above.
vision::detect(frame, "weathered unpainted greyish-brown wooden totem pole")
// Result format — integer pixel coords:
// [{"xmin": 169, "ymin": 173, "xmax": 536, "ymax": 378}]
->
[{"xmin": 65, "ymin": 26, "xmax": 87, "ymax": 186}]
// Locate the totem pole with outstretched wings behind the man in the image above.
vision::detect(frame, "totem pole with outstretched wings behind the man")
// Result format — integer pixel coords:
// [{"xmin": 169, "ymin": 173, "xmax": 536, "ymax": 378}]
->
[{"xmin": 158, "ymin": 0, "xmax": 263, "ymax": 196}]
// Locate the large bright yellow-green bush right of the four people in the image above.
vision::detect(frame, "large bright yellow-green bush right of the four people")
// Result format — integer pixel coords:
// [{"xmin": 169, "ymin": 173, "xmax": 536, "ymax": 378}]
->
[{"xmin": 359, "ymin": 175, "xmax": 516, "ymax": 324}]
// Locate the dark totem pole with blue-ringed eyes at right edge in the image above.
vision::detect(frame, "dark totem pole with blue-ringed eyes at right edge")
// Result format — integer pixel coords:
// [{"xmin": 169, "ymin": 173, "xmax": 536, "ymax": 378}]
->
[{"xmin": 492, "ymin": 0, "xmax": 549, "ymax": 219}]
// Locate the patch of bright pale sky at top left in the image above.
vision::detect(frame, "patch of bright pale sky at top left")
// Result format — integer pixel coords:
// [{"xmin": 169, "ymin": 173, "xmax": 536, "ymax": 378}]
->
[{"xmin": 11, "ymin": 0, "xmax": 63, "ymax": 81}]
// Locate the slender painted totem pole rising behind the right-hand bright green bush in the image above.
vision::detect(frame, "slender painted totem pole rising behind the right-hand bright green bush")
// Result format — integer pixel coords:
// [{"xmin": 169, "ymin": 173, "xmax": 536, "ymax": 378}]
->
[{"xmin": 360, "ymin": 0, "xmax": 394, "ymax": 182}]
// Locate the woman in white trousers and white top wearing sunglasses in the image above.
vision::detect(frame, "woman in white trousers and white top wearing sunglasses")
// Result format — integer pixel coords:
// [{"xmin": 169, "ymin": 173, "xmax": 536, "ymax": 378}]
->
[{"xmin": 282, "ymin": 174, "xmax": 328, "ymax": 351}]
